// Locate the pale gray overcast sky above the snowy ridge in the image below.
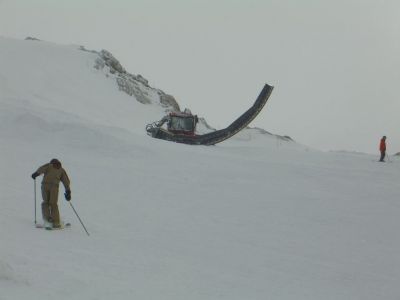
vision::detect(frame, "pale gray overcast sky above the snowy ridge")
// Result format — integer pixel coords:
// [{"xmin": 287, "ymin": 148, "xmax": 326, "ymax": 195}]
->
[{"xmin": 0, "ymin": 0, "xmax": 400, "ymax": 154}]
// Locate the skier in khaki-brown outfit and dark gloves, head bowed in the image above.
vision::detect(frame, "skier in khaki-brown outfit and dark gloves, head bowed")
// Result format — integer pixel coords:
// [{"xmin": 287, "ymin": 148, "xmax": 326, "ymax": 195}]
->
[{"xmin": 32, "ymin": 158, "xmax": 71, "ymax": 228}]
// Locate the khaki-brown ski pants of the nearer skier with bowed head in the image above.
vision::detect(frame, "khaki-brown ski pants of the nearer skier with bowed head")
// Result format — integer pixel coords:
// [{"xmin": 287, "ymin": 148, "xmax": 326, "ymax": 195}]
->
[{"xmin": 42, "ymin": 184, "xmax": 60, "ymax": 225}]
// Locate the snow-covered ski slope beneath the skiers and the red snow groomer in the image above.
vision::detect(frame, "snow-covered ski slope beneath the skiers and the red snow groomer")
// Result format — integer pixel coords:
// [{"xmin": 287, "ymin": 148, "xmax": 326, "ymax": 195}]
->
[{"xmin": 0, "ymin": 38, "xmax": 400, "ymax": 300}]
